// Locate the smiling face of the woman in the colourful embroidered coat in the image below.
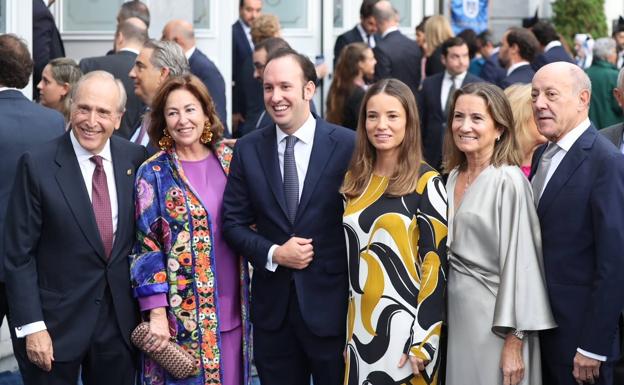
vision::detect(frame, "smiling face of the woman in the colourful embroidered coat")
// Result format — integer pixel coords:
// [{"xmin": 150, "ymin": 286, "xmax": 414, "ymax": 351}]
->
[{"xmin": 165, "ymin": 89, "xmax": 208, "ymax": 150}]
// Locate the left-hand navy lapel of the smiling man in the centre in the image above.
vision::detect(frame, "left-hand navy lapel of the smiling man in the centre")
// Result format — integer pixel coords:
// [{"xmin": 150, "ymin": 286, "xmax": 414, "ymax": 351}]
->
[{"xmin": 256, "ymin": 125, "xmax": 288, "ymax": 218}]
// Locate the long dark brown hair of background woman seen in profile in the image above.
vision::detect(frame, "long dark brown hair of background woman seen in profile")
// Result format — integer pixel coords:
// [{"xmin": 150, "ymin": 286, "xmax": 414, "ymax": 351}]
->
[{"xmin": 327, "ymin": 43, "xmax": 370, "ymax": 125}]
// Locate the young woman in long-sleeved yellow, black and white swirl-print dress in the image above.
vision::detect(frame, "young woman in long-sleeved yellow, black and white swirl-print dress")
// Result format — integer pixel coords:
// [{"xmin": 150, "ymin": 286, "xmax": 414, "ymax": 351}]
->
[{"xmin": 341, "ymin": 79, "xmax": 447, "ymax": 385}]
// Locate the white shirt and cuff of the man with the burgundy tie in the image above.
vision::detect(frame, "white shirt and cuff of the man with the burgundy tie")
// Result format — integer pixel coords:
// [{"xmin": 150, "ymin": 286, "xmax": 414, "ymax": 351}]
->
[{"xmin": 15, "ymin": 131, "xmax": 119, "ymax": 338}]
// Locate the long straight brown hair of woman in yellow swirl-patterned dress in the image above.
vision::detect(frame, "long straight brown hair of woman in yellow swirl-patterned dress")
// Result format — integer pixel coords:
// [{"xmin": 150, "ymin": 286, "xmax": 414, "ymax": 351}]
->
[{"xmin": 340, "ymin": 79, "xmax": 422, "ymax": 198}]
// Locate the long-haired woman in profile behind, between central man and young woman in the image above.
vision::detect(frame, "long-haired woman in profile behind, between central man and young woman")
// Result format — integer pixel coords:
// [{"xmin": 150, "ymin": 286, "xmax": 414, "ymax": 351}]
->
[{"xmin": 327, "ymin": 43, "xmax": 377, "ymax": 130}]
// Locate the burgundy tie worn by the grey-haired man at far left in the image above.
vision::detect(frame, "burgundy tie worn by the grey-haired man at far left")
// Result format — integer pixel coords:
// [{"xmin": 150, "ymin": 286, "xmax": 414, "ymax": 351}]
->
[{"xmin": 91, "ymin": 155, "xmax": 113, "ymax": 258}]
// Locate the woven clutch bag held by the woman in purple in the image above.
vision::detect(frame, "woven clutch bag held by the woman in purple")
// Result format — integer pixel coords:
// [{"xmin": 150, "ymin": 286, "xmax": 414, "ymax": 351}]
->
[{"xmin": 130, "ymin": 322, "xmax": 197, "ymax": 379}]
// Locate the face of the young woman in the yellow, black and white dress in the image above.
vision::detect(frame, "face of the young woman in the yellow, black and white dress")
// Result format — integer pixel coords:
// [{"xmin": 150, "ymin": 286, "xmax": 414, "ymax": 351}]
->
[{"xmin": 365, "ymin": 93, "xmax": 407, "ymax": 158}]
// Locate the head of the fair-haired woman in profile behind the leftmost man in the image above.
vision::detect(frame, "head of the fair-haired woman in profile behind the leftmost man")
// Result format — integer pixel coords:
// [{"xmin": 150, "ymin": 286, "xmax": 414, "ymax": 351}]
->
[{"xmin": 37, "ymin": 57, "xmax": 82, "ymax": 123}]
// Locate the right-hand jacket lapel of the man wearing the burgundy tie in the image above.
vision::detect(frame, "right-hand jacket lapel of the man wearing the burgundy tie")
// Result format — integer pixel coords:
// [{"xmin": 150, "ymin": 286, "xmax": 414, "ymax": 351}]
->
[{"xmin": 109, "ymin": 137, "xmax": 134, "ymax": 262}]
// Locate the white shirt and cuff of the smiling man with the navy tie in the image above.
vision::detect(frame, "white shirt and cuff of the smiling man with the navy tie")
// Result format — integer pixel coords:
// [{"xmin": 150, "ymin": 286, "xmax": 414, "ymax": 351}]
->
[{"xmin": 266, "ymin": 113, "xmax": 316, "ymax": 271}]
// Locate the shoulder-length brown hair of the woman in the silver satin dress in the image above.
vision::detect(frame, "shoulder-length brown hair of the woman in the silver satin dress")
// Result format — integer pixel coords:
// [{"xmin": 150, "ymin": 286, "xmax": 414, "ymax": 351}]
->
[{"xmin": 443, "ymin": 83, "xmax": 522, "ymax": 173}]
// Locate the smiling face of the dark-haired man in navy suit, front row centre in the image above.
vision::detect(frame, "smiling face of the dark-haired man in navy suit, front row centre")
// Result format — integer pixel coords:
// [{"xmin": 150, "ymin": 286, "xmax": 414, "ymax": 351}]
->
[{"xmin": 263, "ymin": 55, "xmax": 315, "ymax": 134}]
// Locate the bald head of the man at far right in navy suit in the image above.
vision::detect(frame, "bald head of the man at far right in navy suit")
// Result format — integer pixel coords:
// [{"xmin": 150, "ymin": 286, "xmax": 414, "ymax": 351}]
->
[{"xmin": 531, "ymin": 62, "xmax": 591, "ymax": 142}]
